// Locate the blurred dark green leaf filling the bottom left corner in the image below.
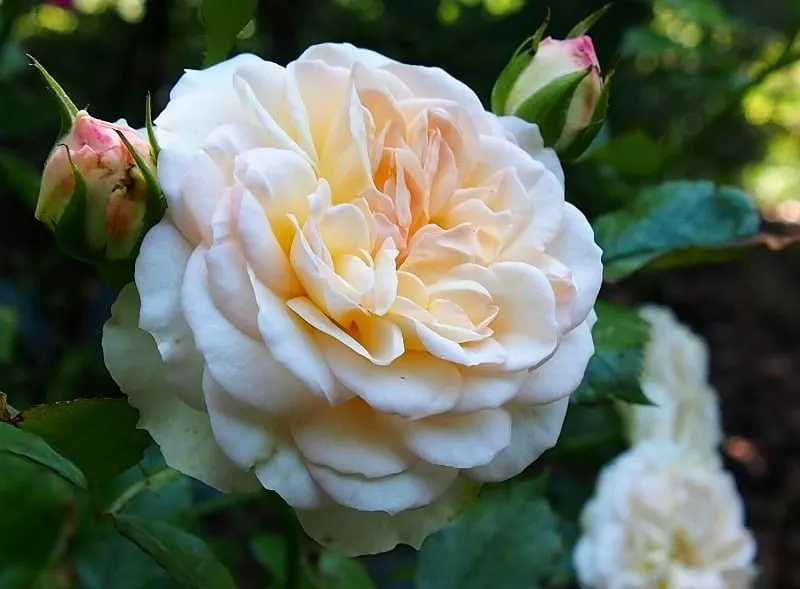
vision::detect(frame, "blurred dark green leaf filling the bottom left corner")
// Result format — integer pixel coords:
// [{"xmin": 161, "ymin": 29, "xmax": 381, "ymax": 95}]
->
[{"xmin": 0, "ymin": 450, "xmax": 74, "ymax": 589}]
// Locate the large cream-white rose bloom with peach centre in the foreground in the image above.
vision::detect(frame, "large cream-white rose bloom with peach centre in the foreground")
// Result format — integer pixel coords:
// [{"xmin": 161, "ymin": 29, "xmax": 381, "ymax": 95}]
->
[{"xmin": 104, "ymin": 44, "xmax": 602, "ymax": 554}]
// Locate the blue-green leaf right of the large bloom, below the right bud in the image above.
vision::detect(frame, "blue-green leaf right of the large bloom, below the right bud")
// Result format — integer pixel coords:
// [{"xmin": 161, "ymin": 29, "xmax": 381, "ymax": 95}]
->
[{"xmin": 594, "ymin": 181, "xmax": 759, "ymax": 280}]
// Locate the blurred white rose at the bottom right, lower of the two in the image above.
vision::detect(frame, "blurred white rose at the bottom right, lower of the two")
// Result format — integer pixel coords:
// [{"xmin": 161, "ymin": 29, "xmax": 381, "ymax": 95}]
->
[{"xmin": 573, "ymin": 439, "xmax": 755, "ymax": 589}]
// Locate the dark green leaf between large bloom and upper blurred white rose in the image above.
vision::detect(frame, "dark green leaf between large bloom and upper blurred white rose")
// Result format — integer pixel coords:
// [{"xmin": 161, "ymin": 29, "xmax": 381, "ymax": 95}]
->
[{"xmin": 572, "ymin": 301, "xmax": 650, "ymax": 405}]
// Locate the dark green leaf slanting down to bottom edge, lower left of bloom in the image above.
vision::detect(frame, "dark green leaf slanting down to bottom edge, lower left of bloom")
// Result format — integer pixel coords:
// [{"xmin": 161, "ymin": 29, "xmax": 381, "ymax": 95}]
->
[{"xmin": 114, "ymin": 515, "xmax": 236, "ymax": 589}]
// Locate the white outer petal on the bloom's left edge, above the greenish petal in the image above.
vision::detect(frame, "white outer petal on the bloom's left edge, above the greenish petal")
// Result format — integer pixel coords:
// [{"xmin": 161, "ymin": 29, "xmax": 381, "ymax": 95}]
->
[{"xmin": 136, "ymin": 220, "xmax": 205, "ymax": 410}]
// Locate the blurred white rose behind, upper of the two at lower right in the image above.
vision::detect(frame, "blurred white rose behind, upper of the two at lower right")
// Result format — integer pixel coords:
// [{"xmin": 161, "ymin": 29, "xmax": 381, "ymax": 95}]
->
[{"xmin": 624, "ymin": 306, "xmax": 722, "ymax": 461}]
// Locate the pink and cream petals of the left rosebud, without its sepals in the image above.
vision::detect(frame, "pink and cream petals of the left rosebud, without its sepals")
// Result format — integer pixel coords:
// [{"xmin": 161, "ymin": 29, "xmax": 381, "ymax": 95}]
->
[{"xmin": 36, "ymin": 111, "xmax": 155, "ymax": 259}]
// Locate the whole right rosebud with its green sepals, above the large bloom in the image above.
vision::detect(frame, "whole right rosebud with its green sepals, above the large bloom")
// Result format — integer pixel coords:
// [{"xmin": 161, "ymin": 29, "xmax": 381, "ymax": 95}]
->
[{"xmin": 492, "ymin": 7, "xmax": 609, "ymax": 160}]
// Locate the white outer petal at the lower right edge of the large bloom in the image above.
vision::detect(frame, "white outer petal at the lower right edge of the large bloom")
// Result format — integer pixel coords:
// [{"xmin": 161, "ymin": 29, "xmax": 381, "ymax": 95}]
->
[{"xmin": 465, "ymin": 397, "xmax": 569, "ymax": 482}]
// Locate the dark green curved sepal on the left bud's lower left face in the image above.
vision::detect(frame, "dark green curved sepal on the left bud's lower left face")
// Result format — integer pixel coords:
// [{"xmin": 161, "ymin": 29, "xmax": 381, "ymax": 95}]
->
[{"xmin": 53, "ymin": 145, "xmax": 105, "ymax": 264}]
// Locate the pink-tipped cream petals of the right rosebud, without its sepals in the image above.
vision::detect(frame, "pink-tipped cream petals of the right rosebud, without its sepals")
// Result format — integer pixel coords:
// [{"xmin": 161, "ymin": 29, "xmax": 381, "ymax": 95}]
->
[{"xmin": 505, "ymin": 35, "xmax": 603, "ymax": 150}]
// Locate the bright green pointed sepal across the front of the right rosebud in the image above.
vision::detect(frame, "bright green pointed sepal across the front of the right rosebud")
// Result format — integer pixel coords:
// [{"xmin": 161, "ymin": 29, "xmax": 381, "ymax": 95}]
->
[{"xmin": 514, "ymin": 67, "xmax": 592, "ymax": 147}]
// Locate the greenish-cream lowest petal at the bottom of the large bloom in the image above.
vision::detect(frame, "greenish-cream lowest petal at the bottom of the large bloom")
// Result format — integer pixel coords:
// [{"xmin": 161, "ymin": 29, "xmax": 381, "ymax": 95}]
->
[{"xmin": 297, "ymin": 477, "xmax": 478, "ymax": 556}]
